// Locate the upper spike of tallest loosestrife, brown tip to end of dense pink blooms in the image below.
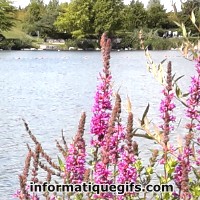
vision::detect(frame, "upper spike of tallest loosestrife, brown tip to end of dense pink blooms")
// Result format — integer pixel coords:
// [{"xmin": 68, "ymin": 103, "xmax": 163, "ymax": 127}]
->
[{"xmin": 90, "ymin": 33, "xmax": 112, "ymax": 148}]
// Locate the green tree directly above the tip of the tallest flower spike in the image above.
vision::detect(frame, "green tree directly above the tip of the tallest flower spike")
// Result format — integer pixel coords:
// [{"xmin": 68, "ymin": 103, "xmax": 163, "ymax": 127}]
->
[{"xmin": 94, "ymin": 0, "xmax": 124, "ymax": 35}]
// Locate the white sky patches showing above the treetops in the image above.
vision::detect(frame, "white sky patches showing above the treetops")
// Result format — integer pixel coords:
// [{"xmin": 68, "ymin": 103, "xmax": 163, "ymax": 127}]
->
[{"xmin": 13, "ymin": 0, "xmax": 180, "ymax": 11}]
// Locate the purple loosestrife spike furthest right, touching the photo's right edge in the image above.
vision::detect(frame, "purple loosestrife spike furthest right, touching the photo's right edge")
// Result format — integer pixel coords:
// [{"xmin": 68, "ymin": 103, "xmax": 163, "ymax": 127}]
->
[{"xmin": 174, "ymin": 58, "xmax": 200, "ymax": 199}]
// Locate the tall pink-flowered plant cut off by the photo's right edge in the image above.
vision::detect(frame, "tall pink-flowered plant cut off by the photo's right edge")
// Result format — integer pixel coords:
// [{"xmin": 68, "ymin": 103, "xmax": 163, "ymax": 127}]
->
[{"xmin": 174, "ymin": 58, "xmax": 200, "ymax": 199}]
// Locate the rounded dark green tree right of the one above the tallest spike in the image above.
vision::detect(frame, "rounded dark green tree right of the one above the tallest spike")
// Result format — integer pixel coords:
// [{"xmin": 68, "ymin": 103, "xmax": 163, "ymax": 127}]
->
[{"xmin": 123, "ymin": 0, "xmax": 147, "ymax": 32}]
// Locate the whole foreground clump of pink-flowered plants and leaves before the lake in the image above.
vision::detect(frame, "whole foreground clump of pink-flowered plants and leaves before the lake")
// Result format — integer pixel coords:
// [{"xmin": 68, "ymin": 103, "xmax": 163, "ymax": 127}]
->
[{"xmin": 13, "ymin": 34, "xmax": 200, "ymax": 200}]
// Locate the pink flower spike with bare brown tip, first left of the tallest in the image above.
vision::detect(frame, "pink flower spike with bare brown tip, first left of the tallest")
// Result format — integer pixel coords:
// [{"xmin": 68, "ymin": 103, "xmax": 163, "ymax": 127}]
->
[{"xmin": 66, "ymin": 113, "xmax": 86, "ymax": 183}]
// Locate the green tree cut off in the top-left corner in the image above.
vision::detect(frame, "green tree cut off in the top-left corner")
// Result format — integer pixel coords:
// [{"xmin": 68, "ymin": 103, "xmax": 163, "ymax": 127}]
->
[{"xmin": 0, "ymin": 0, "xmax": 15, "ymax": 32}]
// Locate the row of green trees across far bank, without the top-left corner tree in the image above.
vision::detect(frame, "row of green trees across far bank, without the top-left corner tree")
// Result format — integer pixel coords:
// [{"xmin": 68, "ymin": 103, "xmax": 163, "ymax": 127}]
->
[{"xmin": 18, "ymin": 0, "xmax": 200, "ymax": 38}]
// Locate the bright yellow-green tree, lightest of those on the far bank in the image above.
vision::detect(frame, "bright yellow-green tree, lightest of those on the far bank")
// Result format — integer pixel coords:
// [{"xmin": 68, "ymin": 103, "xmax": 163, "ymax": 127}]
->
[{"xmin": 55, "ymin": 0, "xmax": 95, "ymax": 38}]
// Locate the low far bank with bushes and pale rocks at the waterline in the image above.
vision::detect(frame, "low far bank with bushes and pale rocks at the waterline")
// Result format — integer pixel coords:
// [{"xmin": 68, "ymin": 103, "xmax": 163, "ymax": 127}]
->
[{"xmin": 0, "ymin": 33, "xmax": 195, "ymax": 51}]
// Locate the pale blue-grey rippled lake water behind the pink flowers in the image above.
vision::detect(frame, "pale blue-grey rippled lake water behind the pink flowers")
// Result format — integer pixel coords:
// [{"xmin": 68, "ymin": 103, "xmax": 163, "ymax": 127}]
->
[{"xmin": 0, "ymin": 51, "xmax": 194, "ymax": 200}]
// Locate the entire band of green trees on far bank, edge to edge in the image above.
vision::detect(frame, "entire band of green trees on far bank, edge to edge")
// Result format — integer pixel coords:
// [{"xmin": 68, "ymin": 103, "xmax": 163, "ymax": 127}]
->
[{"xmin": 0, "ymin": 0, "xmax": 200, "ymax": 49}]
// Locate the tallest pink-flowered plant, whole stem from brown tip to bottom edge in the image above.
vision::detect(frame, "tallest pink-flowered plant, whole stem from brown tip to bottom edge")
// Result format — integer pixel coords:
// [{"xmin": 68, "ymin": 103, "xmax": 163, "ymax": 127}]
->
[{"xmin": 90, "ymin": 33, "xmax": 112, "ymax": 195}]
